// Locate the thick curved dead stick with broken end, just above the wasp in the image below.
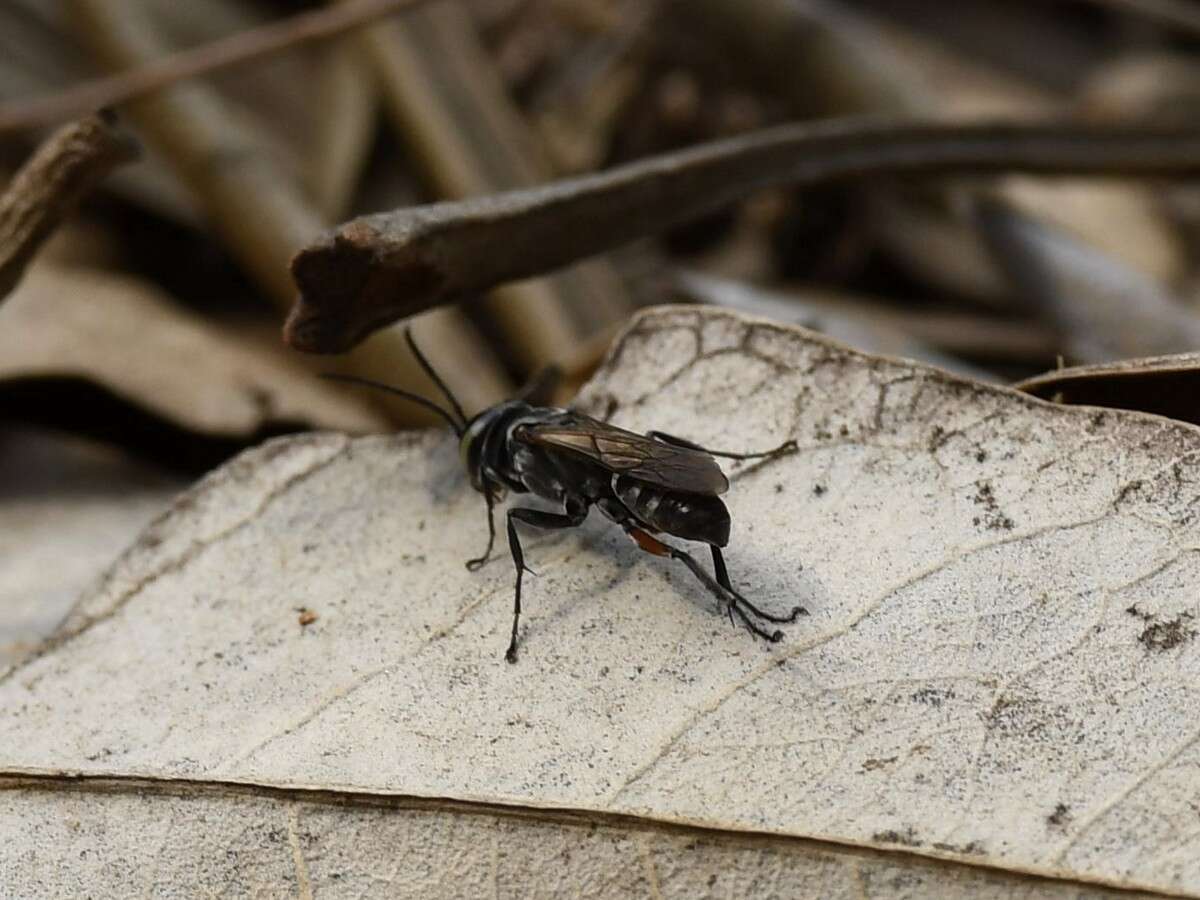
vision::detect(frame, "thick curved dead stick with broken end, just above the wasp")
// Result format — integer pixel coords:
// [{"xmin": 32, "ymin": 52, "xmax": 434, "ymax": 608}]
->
[{"xmin": 284, "ymin": 118, "xmax": 1200, "ymax": 353}]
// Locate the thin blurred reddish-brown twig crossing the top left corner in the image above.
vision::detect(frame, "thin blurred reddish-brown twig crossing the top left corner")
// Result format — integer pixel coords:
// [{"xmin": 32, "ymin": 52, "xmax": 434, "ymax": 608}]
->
[{"xmin": 0, "ymin": 0, "xmax": 426, "ymax": 134}]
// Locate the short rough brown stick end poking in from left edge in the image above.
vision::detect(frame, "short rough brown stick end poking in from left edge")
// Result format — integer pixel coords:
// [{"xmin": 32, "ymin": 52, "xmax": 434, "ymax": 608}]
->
[{"xmin": 0, "ymin": 113, "xmax": 138, "ymax": 300}]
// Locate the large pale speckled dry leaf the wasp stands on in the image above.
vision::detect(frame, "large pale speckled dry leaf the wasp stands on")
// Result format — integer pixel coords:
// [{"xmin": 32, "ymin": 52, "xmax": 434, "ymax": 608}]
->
[{"xmin": 0, "ymin": 308, "xmax": 1200, "ymax": 896}]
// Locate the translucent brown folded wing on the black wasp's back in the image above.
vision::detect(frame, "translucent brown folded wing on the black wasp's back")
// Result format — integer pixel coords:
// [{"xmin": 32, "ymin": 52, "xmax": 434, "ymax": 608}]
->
[{"xmin": 516, "ymin": 414, "xmax": 730, "ymax": 494}]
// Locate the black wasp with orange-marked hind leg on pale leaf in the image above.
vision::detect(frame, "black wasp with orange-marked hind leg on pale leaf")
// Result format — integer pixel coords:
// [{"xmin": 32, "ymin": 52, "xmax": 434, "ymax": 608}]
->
[{"xmin": 326, "ymin": 329, "xmax": 805, "ymax": 662}]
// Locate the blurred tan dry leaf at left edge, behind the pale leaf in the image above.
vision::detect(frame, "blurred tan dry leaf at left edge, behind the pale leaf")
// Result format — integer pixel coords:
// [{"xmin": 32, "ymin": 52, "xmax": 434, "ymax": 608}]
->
[{"xmin": 0, "ymin": 265, "xmax": 386, "ymax": 463}]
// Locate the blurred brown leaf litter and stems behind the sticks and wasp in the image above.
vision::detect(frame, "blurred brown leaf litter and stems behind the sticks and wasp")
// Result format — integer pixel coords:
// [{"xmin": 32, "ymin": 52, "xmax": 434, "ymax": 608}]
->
[{"xmin": 7, "ymin": 0, "xmax": 1200, "ymax": 489}]
